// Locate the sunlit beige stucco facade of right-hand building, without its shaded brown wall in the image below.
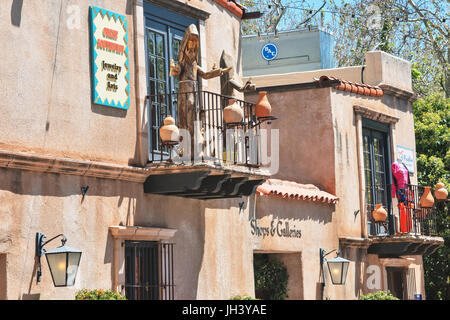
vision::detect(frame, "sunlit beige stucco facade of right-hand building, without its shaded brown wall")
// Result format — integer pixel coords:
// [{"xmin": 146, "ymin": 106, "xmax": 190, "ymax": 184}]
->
[{"xmin": 246, "ymin": 51, "xmax": 442, "ymax": 299}]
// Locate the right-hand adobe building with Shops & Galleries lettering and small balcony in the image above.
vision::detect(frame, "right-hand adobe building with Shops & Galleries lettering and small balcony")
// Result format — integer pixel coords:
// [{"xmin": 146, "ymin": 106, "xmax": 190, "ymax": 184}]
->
[{"xmin": 246, "ymin": 51, "xmax": 443, "ymax": 299}]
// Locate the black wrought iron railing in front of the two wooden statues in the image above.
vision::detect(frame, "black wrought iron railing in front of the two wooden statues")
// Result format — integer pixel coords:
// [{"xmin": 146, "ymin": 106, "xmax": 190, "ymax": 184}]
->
[{"xmin": 147, "ymin": 91, "xmax": 275, "ymax": 168}]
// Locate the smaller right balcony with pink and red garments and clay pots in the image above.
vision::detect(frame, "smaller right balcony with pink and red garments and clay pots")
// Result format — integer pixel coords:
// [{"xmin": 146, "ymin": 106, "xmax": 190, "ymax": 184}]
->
[{"xmin": 366, "ymin": 185, "xmax": 445, "ymax": 257}]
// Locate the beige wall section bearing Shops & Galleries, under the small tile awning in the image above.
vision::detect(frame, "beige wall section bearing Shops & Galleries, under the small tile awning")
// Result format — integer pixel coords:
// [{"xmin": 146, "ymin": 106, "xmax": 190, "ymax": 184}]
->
[{"xmin": 253, "ymin": 196, "xmax": 339, "ymax": 300}]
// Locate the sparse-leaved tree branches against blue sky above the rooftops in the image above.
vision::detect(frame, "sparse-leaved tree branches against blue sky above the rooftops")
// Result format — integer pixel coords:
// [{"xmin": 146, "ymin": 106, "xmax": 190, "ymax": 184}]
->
[{"xmin": 242, "ymin": 0, "xmax": 450, "ymax": 98}]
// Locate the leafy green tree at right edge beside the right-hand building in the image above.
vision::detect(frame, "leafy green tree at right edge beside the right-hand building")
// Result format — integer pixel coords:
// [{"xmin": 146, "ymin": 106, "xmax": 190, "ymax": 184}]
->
[{"xmin": 413, "ymin": 93, "xmax": 450, "ymax": 300}]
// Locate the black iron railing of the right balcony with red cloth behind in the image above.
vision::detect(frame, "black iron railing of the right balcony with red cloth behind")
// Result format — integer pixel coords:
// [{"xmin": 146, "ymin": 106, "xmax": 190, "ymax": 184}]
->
[{"xmin": 366, "ymin": 185, "xmax": 439, "ymax": 236}]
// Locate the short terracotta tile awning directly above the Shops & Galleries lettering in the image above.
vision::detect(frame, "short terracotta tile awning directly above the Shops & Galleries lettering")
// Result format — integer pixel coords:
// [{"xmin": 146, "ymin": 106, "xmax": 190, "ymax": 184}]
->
[{"xmin": 256, "ymin": 179, "xmax": 339, "ymax": 203}]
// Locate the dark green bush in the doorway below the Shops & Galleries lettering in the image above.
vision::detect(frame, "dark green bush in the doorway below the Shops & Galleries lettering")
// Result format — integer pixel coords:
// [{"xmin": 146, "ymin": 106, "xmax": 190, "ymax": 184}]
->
[{"xmin": 254, "ymin": 254, "xmax": 289, "ymax": 300}]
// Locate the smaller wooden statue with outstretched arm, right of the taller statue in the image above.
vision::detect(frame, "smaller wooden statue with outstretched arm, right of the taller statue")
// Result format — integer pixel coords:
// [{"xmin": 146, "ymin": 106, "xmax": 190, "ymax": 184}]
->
[{"xmin": 220, "ymin": 50, "xmax": 256, "ymax": 97}]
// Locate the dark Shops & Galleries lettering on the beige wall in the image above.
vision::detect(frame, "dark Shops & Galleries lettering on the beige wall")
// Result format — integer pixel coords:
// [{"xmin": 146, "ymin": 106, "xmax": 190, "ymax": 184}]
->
[{"xmin": 250, "ymin": 218, "xmax": 302, "ymax": 239}]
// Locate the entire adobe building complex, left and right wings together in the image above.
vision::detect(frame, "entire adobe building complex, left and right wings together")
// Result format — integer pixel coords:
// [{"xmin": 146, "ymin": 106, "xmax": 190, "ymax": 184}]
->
[{"xmin": 0, "ymin": 0, "xmax": 443, "ymax": 300}]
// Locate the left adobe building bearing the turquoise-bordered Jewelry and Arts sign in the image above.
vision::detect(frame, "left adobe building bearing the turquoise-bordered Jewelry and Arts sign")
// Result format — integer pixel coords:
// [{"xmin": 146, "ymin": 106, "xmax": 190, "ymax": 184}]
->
[{"xmin": 0, "ymin": 0, "xmax": 268, "ymax": 299}]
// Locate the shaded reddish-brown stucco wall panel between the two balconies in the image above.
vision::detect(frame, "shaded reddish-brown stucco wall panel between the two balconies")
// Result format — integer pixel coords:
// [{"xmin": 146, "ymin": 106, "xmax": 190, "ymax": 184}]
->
[{"xmin": 246, "ymin": 88, "xmax": 335, "ymax": 194}]
